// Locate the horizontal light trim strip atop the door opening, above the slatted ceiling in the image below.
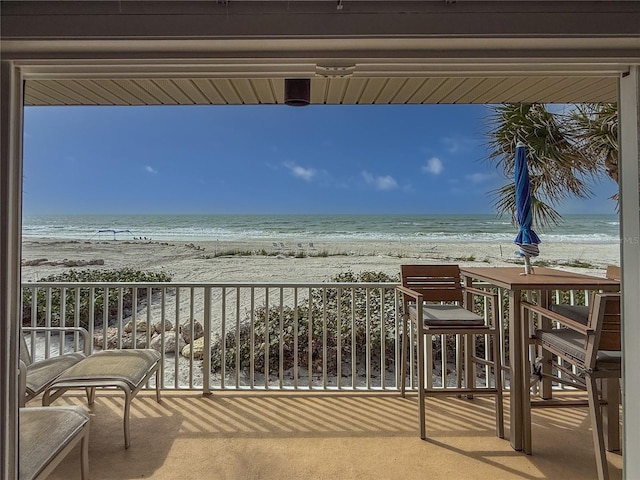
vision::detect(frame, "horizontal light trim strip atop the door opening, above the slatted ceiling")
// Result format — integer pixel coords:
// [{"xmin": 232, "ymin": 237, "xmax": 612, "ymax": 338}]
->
[{"xmin": 13, "ymin": 60, "xmax": 640, "ymax": 80}]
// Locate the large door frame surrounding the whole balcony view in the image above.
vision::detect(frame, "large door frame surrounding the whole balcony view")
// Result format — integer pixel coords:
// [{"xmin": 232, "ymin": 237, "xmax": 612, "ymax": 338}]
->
[{"xmin": 0, "ymin": 1, "xmax": 640, "ymax": 479}]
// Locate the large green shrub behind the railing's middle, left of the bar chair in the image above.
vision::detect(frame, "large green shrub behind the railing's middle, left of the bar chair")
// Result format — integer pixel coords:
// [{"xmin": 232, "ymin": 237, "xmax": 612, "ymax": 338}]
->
[{"xmin": 211, "ymin": 272, "xmax": 398, "ymax": 375}]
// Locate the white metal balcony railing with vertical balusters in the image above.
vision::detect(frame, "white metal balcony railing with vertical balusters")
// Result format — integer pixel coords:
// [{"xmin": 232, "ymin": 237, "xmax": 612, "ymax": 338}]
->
[{"xmin": 22, "ymin": 282, "xmax": 592, "ymax": 393}]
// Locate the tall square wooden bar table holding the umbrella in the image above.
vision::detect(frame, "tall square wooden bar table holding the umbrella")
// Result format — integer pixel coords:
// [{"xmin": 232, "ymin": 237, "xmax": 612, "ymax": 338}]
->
[{"xmin": 460, "ymin": 267, "xmax": 620, "ymax": 454}]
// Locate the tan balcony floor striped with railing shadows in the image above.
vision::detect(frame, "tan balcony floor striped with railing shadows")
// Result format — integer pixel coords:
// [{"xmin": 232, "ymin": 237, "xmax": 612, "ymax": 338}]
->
[{"xmin": 36, "ymin": 391, "xmax": 622, "ymax": 480}]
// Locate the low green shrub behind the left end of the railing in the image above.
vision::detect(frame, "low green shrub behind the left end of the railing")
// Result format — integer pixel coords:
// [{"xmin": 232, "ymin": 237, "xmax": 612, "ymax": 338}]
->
[{"xmin": 22, "ymin": 268, "xmax": 171, "ymax": 328}]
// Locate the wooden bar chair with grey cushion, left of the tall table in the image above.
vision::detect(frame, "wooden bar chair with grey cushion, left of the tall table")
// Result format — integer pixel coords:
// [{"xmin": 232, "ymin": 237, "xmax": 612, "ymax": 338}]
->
[{"xmin": 396, "ymin": 265, "xmax": 504, "ymax": 439}]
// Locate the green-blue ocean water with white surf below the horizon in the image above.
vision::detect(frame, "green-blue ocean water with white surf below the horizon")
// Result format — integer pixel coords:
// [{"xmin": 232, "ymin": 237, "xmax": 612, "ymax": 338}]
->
[{"xmin": 22, "ymin": 215, "xmax": 620, "ymax": 243}]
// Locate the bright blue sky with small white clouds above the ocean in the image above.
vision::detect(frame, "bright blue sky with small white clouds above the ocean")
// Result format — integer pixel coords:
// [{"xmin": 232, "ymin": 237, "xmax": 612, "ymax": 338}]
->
[{"xmin": 23, "ymin": 105, "xmax": 616, "ymax": 214}]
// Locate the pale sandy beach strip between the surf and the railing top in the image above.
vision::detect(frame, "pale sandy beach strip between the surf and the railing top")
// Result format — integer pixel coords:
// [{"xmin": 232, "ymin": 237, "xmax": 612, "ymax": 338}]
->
[{"xmin": 22, "ymin": 238, "xmax": 620, "ymax": 283}]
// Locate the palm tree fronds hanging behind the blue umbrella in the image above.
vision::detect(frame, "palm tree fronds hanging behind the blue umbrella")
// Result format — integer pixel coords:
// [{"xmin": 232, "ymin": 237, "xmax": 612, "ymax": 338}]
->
[{"xmin": 487, "ymin": 103, "xmax": 618, "ymax": 227}]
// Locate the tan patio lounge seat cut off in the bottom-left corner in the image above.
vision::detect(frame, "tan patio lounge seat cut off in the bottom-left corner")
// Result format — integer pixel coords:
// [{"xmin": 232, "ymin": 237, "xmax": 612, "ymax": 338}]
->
[{"xmin": 18, "ymin": 360, "xmax": 90, "ymax": 480}]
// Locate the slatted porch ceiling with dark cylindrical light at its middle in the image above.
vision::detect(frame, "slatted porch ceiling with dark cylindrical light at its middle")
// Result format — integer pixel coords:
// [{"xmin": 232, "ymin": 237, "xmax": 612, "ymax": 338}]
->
[{"xmin": 25, "ymin": 75, "xmax": 617, "ymax": 106}]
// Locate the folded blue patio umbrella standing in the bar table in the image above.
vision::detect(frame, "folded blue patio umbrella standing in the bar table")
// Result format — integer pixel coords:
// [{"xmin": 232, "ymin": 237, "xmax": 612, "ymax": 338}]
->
[{"xmin": 514, "ymin": 143, "xmax": 540, "ymax": 273}]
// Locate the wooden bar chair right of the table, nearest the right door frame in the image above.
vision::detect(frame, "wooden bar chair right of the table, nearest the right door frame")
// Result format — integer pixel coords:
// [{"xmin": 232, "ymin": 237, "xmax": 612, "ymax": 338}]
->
[{"xmin": 522, "ymin": 293, "xmax": 622, "ymax": 480}]
